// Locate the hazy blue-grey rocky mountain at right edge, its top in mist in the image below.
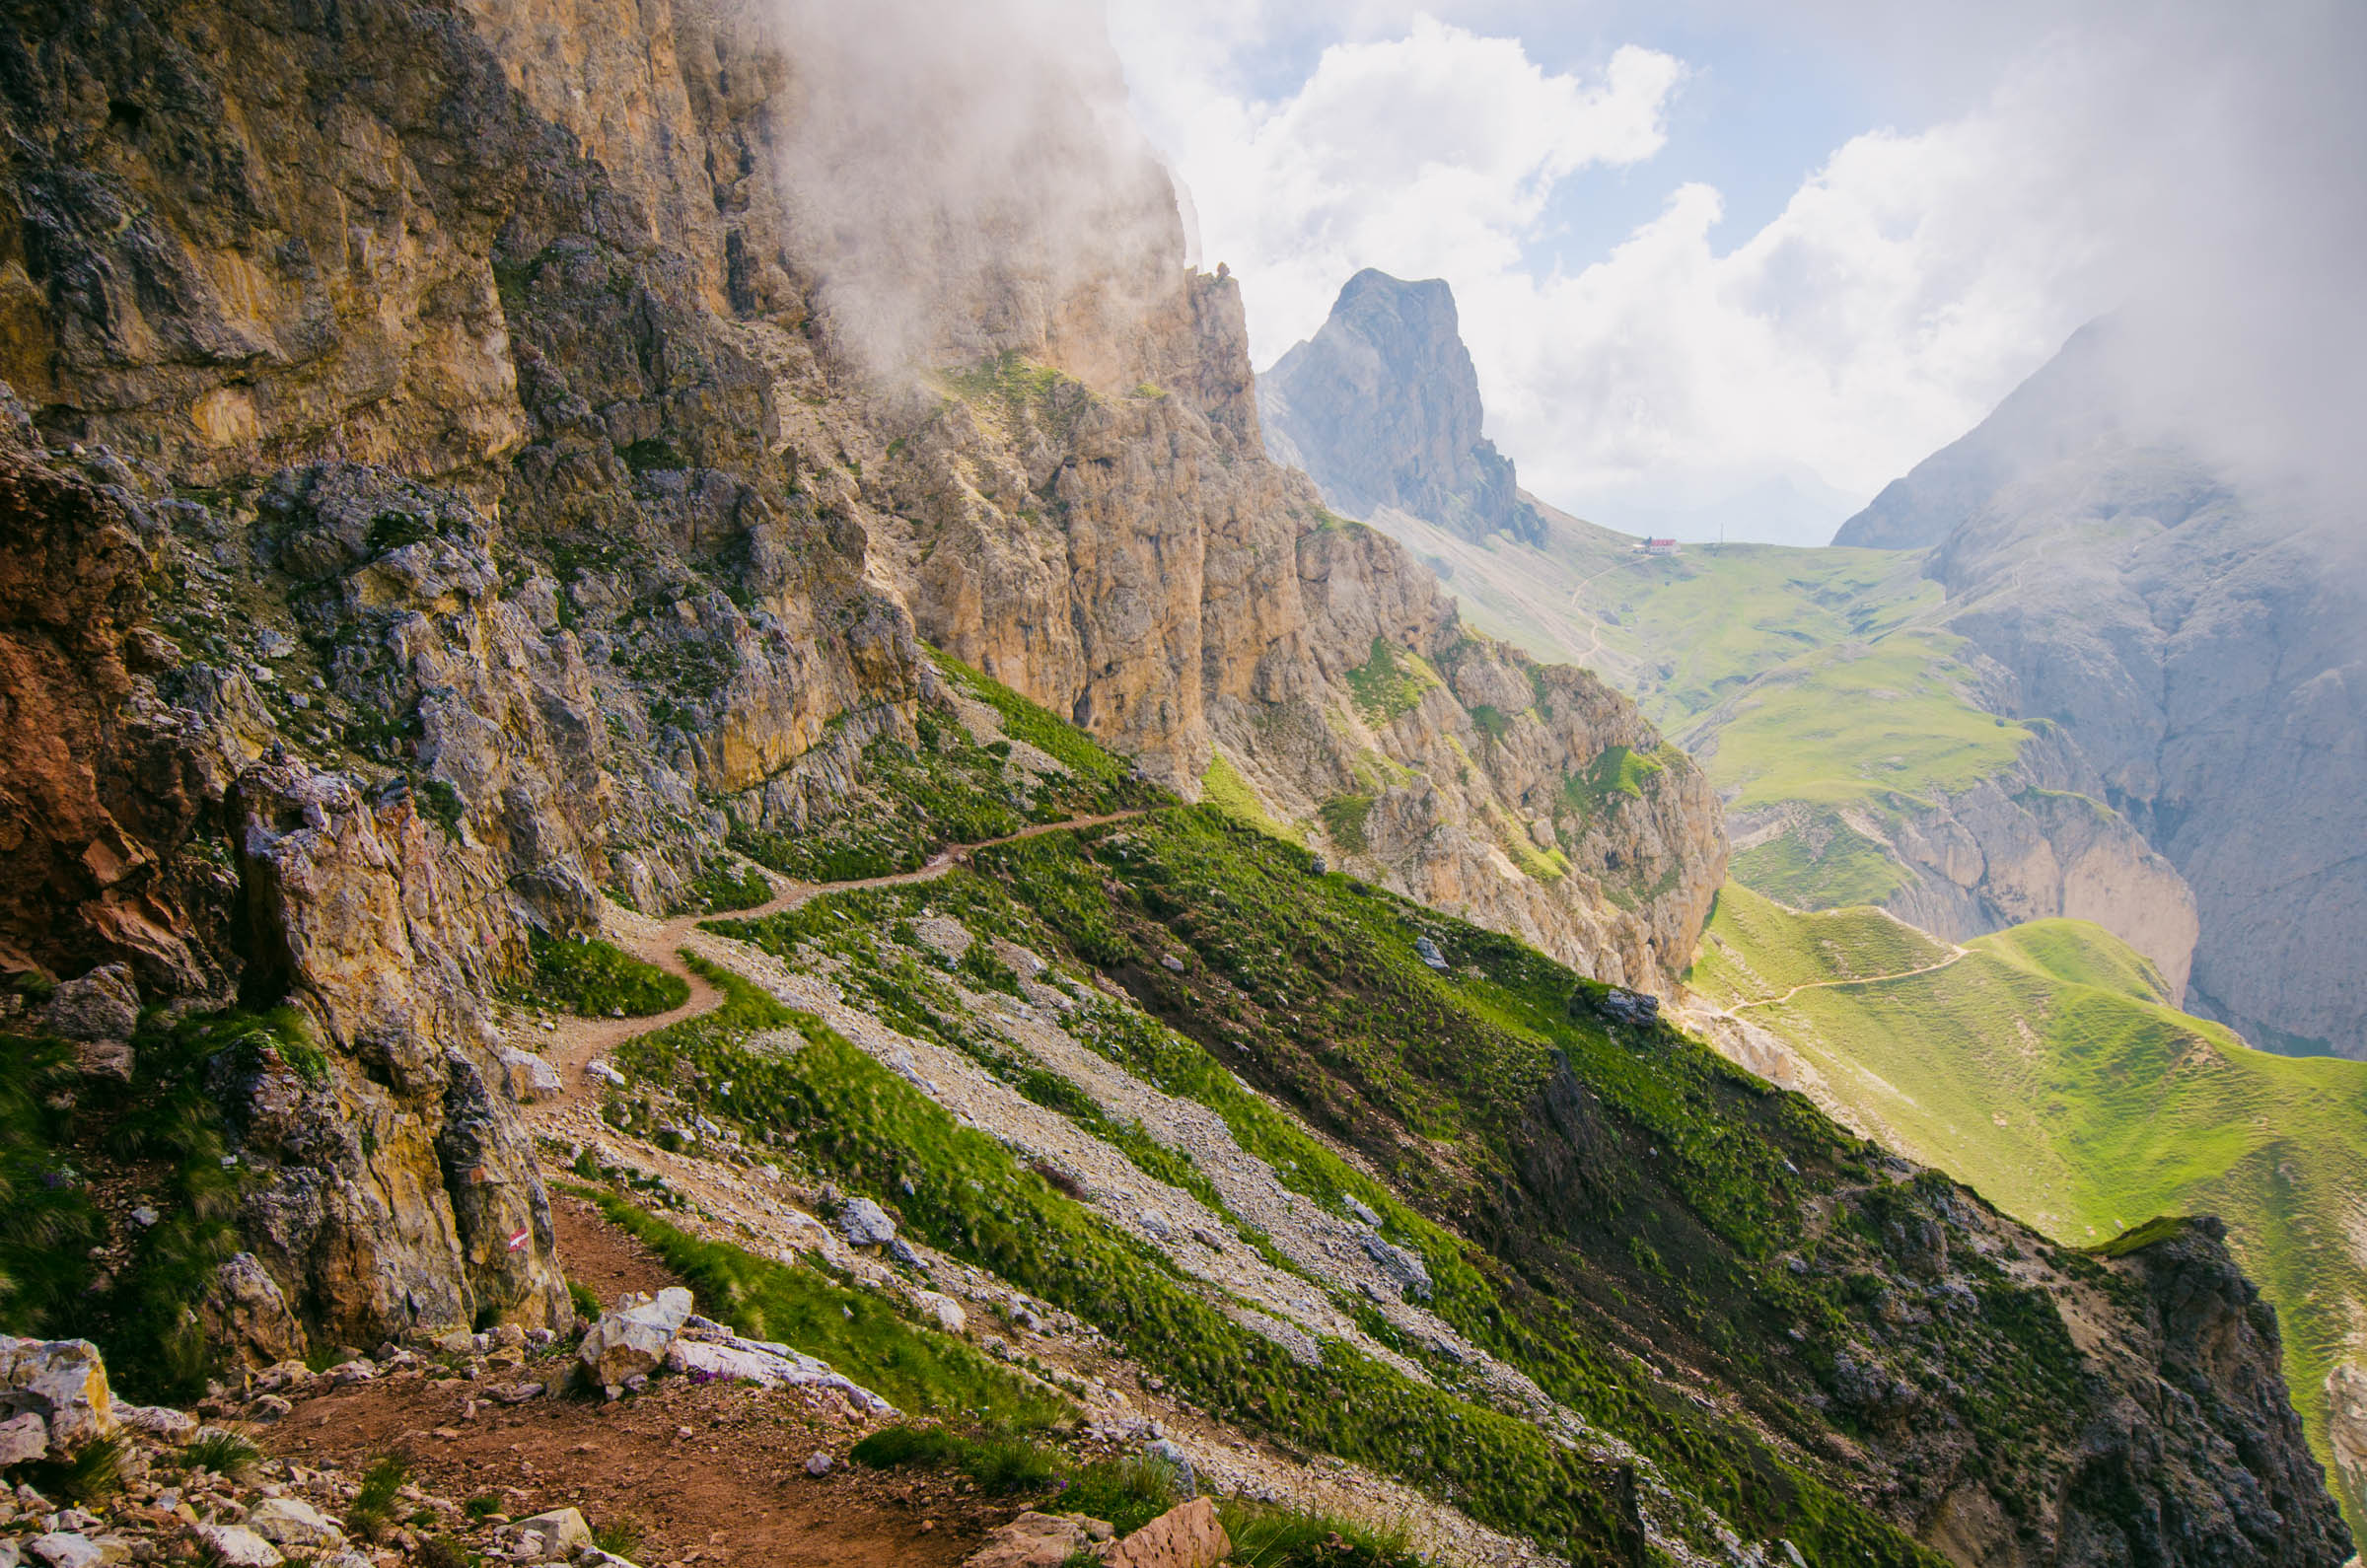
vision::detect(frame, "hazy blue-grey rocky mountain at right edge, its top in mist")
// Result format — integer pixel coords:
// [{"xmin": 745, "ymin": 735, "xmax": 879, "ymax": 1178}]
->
[{"xmin": 1841, "ymin": 329, "xmax": 2367, "ymax": 1056}]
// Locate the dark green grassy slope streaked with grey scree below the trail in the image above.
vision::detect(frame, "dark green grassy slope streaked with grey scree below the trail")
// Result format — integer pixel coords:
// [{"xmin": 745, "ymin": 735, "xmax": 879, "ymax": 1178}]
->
[{"xmin": 606, "ymin": 658, "xmax": 2357, "ymax": 1563}]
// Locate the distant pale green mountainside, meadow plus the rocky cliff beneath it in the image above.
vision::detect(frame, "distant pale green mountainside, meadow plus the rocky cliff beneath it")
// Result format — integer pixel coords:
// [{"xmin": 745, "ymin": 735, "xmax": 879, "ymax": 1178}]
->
[{"xmin": 1334, "ymin": 447, "xmax": 2196, "ymax": 995}]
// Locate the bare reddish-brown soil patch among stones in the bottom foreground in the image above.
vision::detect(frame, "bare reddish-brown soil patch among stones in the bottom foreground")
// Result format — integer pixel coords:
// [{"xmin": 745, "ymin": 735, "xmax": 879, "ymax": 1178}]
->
[{"xmin": 258, "ymin": 1357, "xmax": 1016, "ymax": 1568}]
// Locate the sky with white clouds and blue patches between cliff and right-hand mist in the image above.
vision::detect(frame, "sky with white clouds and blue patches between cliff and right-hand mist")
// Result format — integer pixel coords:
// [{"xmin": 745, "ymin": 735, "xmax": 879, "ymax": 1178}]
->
[{"xmin": 1111, "ymin": 0, "xmax": 2168, "ymax": 542}]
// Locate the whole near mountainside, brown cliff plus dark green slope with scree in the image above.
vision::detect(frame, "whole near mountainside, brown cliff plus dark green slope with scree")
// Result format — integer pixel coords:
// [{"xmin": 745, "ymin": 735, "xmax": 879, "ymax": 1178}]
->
[{"xmin": 0, "ymin": 0, "xmax": 2345, "ymax": 1568}]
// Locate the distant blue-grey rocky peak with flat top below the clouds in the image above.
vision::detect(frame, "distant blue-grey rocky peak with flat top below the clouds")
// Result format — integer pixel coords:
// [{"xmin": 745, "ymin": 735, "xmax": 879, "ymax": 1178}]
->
[{"xmin": 1256, "ymin": 267, "xmax": 1545, "ymax": 544}]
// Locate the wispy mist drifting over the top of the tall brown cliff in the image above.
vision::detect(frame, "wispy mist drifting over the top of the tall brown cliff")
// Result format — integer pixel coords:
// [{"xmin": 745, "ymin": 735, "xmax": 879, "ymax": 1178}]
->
[{"xmin": 764, "ymin": 0, "xmax": 1184, "ymax": 379}]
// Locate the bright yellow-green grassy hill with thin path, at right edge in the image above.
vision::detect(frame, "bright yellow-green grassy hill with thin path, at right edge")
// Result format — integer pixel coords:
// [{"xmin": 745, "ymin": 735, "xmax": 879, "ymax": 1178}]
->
[{"xmin": 1692, "ymin": 886, "xmax": 2367, "ymax": 1521}]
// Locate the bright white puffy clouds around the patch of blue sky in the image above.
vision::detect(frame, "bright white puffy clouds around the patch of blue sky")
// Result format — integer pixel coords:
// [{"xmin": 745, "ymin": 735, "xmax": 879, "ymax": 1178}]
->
[{"xmin": 1117, "ymin": 7, "xmax": 2112, "ymax": 539}]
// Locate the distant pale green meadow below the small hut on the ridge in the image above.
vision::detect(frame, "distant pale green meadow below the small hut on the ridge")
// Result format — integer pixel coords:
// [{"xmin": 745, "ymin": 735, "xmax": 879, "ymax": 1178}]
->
[{"xmin": 1383, "ymin": 514, "xmax": 2031, "ymax": 907}]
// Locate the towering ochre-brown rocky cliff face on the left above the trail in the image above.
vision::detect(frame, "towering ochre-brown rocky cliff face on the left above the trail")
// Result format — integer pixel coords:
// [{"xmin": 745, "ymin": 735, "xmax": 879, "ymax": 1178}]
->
[{"xmin": 0, "ymin": 0, "xmax": 1723, "ymax": 1357}]
